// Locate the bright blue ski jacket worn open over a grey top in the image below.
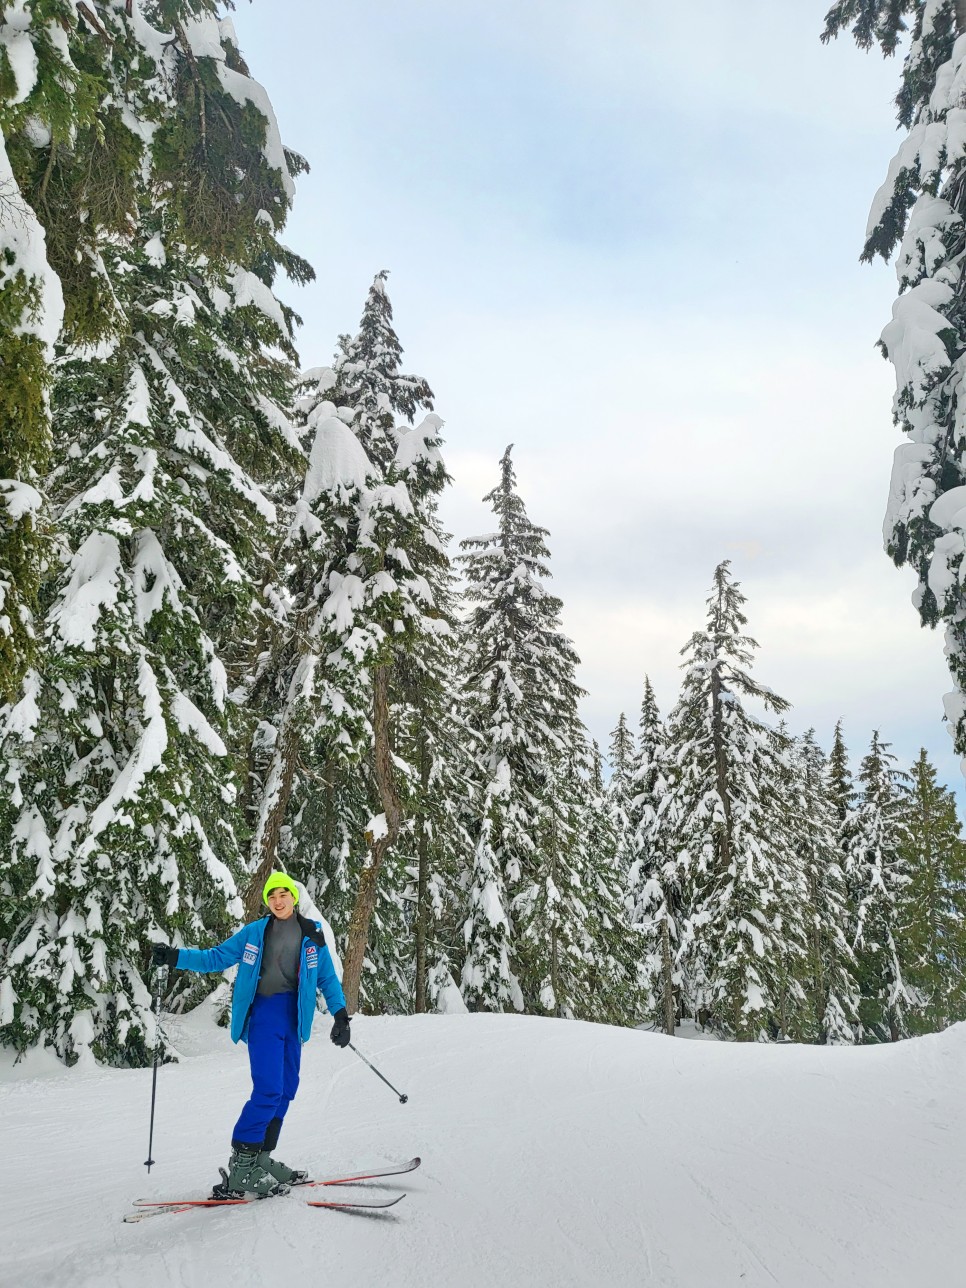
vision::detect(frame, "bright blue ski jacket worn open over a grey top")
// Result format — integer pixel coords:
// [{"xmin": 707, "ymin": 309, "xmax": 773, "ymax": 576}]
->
[{"xmin": 178, "ymin": 917, "xmax": 345, "ymax": 1042}]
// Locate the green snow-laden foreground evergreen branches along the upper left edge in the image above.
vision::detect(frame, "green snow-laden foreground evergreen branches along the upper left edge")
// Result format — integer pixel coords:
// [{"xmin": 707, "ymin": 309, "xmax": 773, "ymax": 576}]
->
[{"xmin": 0, "ymin": 0, "xmax": 144, "ymax": 701}]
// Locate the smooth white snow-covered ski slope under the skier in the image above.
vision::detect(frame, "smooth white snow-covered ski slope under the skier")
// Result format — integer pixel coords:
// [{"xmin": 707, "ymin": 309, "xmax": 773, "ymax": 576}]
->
[{"xmin": 0, "ymin": 1009, "xmax": 966, "ymax": 1288}]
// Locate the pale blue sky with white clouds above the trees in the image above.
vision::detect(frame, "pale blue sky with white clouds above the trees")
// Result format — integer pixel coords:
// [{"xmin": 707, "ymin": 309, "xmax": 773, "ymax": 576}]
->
[{"xmin": 225, "ymin": 0, "xmax": 962, "ymax": 799}]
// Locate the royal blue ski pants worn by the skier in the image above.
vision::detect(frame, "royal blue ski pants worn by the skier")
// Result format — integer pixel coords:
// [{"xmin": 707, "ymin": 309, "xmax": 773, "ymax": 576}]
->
[{"xmin": 232, "ymin": 993, "xmax": 301, "ymax": 1145}]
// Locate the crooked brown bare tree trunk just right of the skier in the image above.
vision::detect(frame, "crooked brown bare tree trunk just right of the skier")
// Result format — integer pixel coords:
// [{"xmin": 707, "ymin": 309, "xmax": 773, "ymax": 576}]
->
[{"xmin": 343, "ymin": 662, "xmax": 402, "ymax": 1015}]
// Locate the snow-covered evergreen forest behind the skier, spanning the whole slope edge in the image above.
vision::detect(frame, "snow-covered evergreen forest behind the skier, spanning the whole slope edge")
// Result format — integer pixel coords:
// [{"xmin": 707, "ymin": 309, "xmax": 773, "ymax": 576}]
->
[{"xmin": 0, "ymin": 0, "xmax": 962, "ymax": 1064}]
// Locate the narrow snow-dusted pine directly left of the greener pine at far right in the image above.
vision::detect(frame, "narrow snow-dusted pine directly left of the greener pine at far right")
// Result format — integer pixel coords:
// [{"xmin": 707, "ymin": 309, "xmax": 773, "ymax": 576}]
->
[{"xmin": 846, "ymin": 730, "xmax": 909, "ymax": 1042}]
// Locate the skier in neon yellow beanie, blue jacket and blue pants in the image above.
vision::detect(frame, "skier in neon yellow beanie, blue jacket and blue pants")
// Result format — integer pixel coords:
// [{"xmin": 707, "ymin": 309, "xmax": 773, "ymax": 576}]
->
[{"xmin": 152, "ymin": 872, "xmax": 350, "ymax": 1195}]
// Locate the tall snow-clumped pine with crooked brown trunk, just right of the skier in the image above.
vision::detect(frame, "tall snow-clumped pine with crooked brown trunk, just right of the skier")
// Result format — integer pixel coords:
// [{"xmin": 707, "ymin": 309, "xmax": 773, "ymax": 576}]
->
[{"xmin": 270, "ymin": 273, "xmax": 452, "ymax": 1009}]
